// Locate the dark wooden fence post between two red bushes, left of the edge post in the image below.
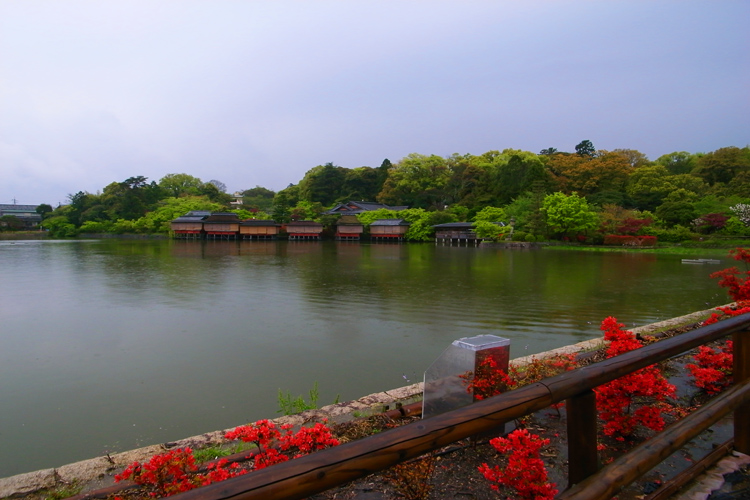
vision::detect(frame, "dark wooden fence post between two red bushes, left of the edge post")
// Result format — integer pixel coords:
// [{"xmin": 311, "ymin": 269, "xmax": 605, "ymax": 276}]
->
[{"xmin": 565, "ymin": 390, "xmax": 599, "ymax": 488}]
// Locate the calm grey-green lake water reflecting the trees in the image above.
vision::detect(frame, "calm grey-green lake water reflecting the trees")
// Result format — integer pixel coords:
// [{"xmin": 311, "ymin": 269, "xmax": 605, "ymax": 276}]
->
[{"xmin": 0, "ymin": 240, "xmax": 733, "ymax": 477}]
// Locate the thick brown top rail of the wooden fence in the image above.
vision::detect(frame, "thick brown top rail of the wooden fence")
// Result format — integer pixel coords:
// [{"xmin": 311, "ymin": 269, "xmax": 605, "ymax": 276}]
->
[{"xmin": 174, "ymin": 315, "xmax": 750, "ymax": 500}]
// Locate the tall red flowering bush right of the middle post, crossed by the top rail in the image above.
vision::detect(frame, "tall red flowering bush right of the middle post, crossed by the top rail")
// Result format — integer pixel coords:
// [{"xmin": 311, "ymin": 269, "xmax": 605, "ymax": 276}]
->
[{"xmin": 594, "ymin": 316, "xmax": 676, "ymax": 441}]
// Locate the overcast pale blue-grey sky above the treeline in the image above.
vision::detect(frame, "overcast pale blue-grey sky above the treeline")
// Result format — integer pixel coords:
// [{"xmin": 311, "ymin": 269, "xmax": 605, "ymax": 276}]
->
[{"xmin": 0, "ymin": 0, "xmax": 750, "ymax": 206}]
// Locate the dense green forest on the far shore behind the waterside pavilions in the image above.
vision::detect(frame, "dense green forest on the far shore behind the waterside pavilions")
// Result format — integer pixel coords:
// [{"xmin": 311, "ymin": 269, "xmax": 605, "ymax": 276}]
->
[{"xmin": 16, "ymin": 140, "xmax": 750, "ymax": 243}]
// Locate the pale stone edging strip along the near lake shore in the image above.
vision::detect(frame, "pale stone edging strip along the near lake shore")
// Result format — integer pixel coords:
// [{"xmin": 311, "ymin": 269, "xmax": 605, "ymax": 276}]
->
[{"xmin": 0, "ymin": 309, "xmax": 728, "ymax": 498}]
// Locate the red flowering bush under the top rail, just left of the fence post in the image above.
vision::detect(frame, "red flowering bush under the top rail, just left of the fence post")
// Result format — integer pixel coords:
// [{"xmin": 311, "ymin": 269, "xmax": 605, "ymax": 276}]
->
[{"xmin": 479, "ymin": 429, "xmax": 557, "ymax": 500}]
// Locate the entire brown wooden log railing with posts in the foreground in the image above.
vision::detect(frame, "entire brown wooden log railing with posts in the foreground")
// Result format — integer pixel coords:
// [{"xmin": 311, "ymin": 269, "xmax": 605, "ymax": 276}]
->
[{"xmin": 174, "ymin": 315, "xmax": 750, "ymax": 500}]
